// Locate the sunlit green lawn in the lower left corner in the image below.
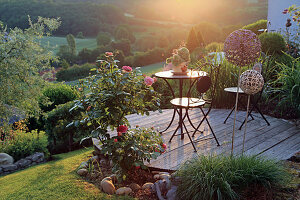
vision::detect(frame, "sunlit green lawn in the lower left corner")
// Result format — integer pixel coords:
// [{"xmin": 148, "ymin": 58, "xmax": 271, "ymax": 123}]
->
[{"xmin": 0, "ymin": 148, "xmax": 132, "ymax": 200}]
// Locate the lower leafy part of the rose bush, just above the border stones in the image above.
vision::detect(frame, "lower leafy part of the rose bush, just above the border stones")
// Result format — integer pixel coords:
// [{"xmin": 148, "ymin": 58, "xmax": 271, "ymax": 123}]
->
[{"xmin": 101, "ymin": 128, "xmax": 166, "ymax": 174}]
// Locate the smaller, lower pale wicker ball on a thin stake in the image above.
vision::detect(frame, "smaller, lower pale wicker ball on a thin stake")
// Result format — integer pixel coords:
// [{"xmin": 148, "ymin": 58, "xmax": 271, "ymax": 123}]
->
[{"xmin": 240, "ymin": 70, "xmax": 264, "ymax": 94}]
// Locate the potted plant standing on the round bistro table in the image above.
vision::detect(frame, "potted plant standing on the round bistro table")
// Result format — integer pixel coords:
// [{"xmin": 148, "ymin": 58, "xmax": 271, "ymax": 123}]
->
[{"xmin": 166, "ymin": 47, "xmax": 191, "ymax": 74}]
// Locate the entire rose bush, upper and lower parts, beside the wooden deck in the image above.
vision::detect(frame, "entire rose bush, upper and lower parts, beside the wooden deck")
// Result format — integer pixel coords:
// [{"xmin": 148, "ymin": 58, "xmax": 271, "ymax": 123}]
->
[{"xmin": 69, "ymin": 52, "xmax": 161, "ymax": 176}]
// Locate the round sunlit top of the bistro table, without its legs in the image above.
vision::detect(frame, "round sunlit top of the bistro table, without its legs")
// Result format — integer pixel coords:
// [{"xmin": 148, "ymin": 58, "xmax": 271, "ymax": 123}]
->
[{"xmin": 155, "ymin": 70, "xmax": 207, "ymax": 79}]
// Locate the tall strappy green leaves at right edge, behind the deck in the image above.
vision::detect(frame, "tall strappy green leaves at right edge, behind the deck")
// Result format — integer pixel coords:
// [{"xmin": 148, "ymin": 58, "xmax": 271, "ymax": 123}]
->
[{"xmin": 271, "ymin": 55, "xmax": 300, "ymax": 117}]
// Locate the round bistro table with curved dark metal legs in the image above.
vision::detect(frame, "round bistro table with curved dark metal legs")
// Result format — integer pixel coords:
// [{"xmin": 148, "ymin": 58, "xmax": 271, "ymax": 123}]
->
[{"xmin": 155, "ymin": 70, "xmax": 207, "ymax": 139}]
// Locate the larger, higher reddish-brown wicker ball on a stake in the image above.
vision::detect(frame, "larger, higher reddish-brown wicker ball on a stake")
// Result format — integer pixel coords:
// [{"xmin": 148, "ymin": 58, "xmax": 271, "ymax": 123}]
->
[{"xmin": 224, "ymin": 29, "xmax": 261, "ymax": 67}]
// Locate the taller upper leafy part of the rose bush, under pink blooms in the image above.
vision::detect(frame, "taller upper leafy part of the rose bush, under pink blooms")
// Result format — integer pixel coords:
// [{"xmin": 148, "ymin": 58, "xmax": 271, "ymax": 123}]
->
[{"xmin": 72, "ymin": 52, "xmax": 159, "ymax": 138}]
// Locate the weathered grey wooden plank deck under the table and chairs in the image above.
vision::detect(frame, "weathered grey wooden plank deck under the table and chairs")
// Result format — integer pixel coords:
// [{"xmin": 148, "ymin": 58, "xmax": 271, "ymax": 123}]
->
[{"xmin": 93, "ymin": 109, "xmax": 300, "ymax": 169}]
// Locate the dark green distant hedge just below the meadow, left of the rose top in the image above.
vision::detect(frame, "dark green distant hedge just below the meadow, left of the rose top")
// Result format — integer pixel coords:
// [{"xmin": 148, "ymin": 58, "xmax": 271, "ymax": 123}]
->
[{"xmin": 56, "ymin": 62, "xmax": 95, "ymax": 81}]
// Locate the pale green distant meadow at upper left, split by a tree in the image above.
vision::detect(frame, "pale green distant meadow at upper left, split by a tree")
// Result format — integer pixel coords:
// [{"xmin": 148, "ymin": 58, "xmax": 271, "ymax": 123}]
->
[{"xmin": 41, "ymin": 36, "xmax": 97, "ymax": 54}]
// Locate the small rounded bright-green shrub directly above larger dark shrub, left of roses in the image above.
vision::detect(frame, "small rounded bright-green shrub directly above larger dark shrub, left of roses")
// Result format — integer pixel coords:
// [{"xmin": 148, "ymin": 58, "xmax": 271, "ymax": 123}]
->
[{"xmin": 40, "ymin": 83, "xmax": 78, "ymax": 112}]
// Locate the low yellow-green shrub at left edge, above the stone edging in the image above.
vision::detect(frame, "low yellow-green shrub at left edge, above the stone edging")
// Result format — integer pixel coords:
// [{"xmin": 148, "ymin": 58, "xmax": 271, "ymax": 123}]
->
[{"xmin": 0, "ymin": 130, "xmax": 49, "ymax": 161}]
